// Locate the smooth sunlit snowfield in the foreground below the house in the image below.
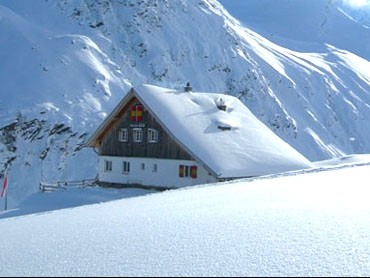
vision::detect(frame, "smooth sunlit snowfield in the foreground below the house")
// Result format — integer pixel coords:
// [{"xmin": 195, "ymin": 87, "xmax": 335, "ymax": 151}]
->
[{"xmin": 0, "ymin": 156, "xmax": 370, "ymax": 276}]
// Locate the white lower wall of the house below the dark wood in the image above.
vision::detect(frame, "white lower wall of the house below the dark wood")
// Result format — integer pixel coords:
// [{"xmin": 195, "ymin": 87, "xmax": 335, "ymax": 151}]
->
[{"xmin": 99, "ymin": 156, "xmax": 217, "ymax": 187}]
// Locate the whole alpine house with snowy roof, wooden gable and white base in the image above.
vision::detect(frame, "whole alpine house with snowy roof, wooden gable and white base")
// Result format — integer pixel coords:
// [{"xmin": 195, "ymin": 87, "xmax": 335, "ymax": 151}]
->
[{"xmin": 87, "ymin": 84, "xmax": 312, "ymax": 188}]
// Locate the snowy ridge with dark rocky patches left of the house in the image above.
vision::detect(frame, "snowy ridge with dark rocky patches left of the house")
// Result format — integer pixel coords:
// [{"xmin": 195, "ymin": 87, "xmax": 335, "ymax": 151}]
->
[{"xmin": 0, "ymin": 1, "xmax": 130, "ymax": 204}]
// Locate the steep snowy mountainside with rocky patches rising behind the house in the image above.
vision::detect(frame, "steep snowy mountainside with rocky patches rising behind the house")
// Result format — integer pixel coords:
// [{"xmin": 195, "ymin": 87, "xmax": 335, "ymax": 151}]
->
[{"xmin": 0, "ymin": 0, "xmax": 370, "ymax": 207}]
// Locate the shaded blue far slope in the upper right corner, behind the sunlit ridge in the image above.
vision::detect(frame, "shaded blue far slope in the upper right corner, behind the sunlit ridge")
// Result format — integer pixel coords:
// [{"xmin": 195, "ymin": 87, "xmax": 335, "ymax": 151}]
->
[{"xmin": 220, "ymin": 0, "xmax": 370, "ymax": 59}]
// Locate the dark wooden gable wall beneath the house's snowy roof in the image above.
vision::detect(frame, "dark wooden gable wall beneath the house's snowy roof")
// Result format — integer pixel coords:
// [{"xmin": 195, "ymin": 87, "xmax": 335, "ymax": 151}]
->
[{"xmin": 99, "ymin": 96, "xmax": 193, "ymax": 160}]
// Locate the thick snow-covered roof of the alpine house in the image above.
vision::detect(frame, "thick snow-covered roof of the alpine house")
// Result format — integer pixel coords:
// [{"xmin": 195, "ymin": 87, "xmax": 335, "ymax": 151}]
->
[{"xmin": 88, "ymin": 84, "xmax": 312, "ymax": 178}]
